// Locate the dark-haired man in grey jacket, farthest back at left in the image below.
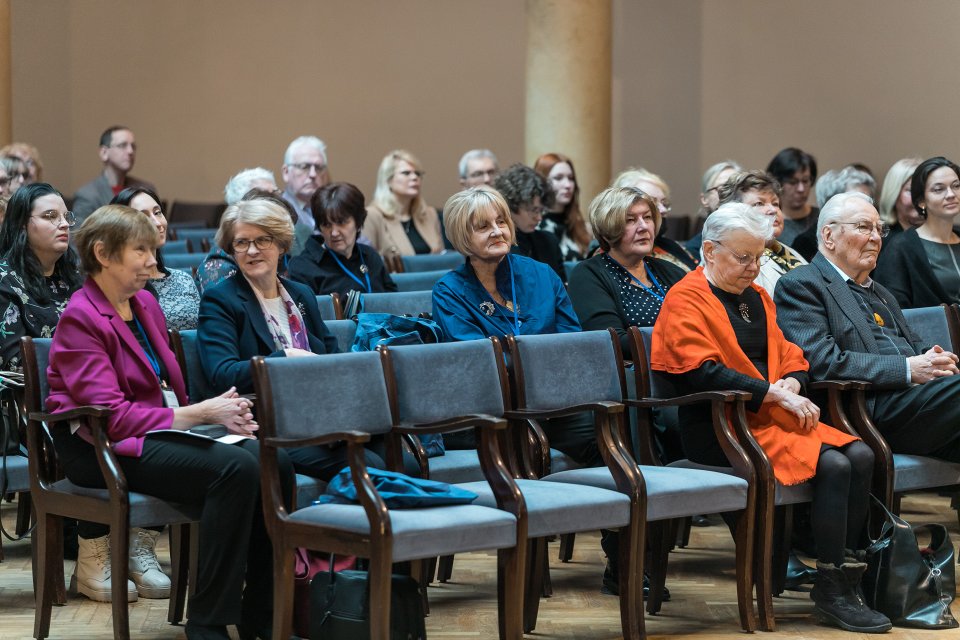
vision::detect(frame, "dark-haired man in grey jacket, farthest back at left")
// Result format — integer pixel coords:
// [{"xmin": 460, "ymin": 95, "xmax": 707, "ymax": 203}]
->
[{"xmin": 73, "ymin": 126, "xmax": 156, "ymax": 223}]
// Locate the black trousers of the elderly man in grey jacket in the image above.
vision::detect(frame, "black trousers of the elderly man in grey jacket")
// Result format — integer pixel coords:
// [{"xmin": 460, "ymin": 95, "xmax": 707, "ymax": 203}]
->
[{"xmin": 873, "ymin": 376, "xmax": 960, "ymax": 462}]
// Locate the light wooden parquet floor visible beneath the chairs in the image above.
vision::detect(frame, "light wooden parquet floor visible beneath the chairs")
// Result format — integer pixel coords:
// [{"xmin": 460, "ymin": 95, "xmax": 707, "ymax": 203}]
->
[{"xmin": 0, "ymin": 495, "xmax": 960, "ymax": 640}]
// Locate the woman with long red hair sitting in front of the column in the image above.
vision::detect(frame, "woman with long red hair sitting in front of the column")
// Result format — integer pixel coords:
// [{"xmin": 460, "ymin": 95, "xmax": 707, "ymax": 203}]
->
[{"xmin": 533, "ymin": 153, "xmax": 593, "ymax": 261}]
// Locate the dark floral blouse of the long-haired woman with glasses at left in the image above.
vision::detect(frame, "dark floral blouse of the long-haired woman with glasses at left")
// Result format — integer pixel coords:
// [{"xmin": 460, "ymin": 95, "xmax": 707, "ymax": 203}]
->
[{"xmin": 0, "ymin": 261, "xmax": 74, "ymax": 371}]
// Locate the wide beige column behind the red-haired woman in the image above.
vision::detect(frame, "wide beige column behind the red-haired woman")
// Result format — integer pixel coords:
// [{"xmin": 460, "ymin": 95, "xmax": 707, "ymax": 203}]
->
[{"xmin": 525, "ymin": 0, "xmax": 613, "ymax": 206}]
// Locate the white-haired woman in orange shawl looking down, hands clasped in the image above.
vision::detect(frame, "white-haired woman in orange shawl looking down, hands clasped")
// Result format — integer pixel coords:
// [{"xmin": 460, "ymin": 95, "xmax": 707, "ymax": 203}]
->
[{"xmin": 650, "ymin": 203, "xmax": 890, "ymax": 633}]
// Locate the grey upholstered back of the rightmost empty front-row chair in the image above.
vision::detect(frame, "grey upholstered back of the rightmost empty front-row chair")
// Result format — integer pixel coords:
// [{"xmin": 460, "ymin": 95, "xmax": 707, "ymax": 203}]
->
[{"xmin": 516, "ymin": 331, "xmax": 622, "ymax": 410}]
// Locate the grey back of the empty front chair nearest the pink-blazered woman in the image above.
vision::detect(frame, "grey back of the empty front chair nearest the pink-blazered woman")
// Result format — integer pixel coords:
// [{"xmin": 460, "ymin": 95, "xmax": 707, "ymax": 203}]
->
[{"xmin": 258, "ymin": 351, "xmax": 393, "ymax": 439}]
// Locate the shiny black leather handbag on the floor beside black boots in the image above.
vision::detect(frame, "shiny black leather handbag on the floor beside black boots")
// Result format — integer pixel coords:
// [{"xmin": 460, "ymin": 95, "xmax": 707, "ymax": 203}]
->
[{"xmin": 862, "ymin": 498, "xmax": 960, "ymax": 629}]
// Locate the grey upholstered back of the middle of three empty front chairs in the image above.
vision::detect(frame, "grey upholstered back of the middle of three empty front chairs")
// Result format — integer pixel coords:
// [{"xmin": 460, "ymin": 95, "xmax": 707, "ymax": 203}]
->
[{"xmin": 390, "ymin": 340, "xmax": 503, "ymax": 423}]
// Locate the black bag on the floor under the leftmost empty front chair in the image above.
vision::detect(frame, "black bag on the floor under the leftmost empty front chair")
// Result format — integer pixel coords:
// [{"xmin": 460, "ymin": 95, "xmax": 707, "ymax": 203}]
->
[{"xmin": 310, "ymin": 556, "xmax": 427, "ymax": 640}]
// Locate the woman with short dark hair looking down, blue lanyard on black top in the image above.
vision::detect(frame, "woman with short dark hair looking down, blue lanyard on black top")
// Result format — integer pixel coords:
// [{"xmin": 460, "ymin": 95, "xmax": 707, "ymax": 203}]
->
[{"xmin": 290, "ymin": 182, "xmax": 397, "ymax": 298}]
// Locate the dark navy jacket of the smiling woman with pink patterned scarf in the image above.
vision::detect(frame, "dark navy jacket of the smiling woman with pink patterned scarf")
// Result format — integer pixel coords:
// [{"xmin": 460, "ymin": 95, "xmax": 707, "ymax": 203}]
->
[{"xmin": 197, "ymin": 273, "xmax": 338, "ymax": 393}]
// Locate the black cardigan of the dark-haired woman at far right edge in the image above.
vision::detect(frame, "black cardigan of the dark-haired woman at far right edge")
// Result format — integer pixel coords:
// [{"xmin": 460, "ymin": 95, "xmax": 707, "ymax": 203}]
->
[{"xmin": 873, "ymin": 229, "xmax": 958, "ymax": 309}]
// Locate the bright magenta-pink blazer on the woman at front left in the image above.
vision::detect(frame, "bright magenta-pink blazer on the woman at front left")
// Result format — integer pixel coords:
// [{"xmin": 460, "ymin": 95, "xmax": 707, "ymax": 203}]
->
[{"xmin": 47, "ymin": 278, "xmax": 187, "ymax": 457}]
